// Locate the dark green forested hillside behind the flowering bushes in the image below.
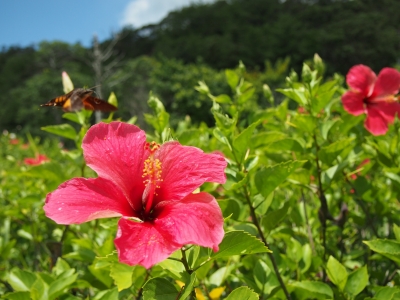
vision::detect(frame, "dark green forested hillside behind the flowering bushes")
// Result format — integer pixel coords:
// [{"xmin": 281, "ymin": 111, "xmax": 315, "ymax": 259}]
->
[{"xmin": 0, "ymin": 0, "xmax": 400, "ymax": 133}]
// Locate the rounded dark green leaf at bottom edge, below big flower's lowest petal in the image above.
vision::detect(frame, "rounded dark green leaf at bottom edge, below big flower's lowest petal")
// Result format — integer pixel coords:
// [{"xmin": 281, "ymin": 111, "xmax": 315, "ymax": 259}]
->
[{"xmin": 143, "ymin": 277, "xmax": 178, "ymax": 300}]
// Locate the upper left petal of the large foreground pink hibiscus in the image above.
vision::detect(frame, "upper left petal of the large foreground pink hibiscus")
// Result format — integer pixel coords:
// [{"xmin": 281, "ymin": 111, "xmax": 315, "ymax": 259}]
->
[{"xmin": 82, "ymin": 122, "xmax": 146, "ymax": 211}]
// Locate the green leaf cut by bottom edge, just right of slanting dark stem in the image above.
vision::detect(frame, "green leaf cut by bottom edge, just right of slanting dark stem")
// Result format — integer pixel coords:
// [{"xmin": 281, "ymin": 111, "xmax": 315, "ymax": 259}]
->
[{"xmin": 288, "ymin": 281, "xmax": 333, "ymax": 300}]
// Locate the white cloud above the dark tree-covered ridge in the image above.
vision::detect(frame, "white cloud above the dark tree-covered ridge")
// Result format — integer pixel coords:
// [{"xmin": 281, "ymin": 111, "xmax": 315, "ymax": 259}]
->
[{"xmin": 121, "ymin": 0, "xmax": 214, "ymax": 27}]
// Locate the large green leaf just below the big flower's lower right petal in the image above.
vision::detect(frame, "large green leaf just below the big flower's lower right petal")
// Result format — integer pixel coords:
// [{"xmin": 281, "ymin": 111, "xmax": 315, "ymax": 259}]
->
[{"xmin": 211, "ymin": 231, "xmax": 271, "ymax": 259}]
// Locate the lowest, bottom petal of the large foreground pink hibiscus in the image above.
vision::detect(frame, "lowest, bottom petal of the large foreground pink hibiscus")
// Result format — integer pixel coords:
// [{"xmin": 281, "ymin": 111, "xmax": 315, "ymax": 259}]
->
[{"xmin": 114, "ymin": 218, "xmax": 182, "ymax": 269}]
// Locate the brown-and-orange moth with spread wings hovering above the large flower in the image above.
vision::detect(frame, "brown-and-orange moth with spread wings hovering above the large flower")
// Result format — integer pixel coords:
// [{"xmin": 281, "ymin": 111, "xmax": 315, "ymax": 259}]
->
[{"xmin": 40, "ymin": 88, "xmax": 117, "ymax": 112}]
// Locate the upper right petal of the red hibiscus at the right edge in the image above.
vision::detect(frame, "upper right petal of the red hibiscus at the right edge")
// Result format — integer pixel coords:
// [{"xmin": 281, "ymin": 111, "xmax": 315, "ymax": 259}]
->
[{"xmin": 371, "ymin": 68, "xmax": 400, "ymax": 98}]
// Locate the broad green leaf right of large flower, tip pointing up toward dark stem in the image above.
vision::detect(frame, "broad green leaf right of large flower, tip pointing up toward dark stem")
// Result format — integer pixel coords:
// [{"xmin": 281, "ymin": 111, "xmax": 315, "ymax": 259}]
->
[{"xmin": 255, "ymin": 161, "xmax": 305, "ymax": 197}]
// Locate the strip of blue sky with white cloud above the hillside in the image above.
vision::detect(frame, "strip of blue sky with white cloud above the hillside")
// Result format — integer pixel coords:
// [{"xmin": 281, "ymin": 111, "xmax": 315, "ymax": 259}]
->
[{"xmin": 0, "ymin": 0, "xmax": 213, "ymax": 49}]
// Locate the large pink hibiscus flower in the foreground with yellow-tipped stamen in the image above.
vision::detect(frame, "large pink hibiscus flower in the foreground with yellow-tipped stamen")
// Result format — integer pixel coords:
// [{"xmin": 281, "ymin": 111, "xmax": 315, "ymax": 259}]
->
[{"xmin": 44, "ymin": 122, "xmax": 227, "ymax": 268}]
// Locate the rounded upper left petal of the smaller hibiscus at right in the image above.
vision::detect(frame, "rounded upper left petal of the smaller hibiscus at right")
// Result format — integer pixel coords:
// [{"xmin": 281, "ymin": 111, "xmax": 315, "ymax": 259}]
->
[{"xmin": 346, "ymin": 65, "xmax": 376, "ymax": 96}]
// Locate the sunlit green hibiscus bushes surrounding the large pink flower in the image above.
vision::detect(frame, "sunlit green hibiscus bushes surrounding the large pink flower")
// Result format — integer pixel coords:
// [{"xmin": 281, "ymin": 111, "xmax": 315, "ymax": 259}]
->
[{"xmin": 0, "ymin": 54, "xmax": 400, "ymax": 300}]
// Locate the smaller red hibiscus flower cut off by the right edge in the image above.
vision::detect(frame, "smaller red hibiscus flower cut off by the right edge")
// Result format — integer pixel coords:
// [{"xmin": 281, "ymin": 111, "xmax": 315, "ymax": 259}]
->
[{"xmin": 342, "ymin": 65, "xmax": 400, "ymax": 135}]
